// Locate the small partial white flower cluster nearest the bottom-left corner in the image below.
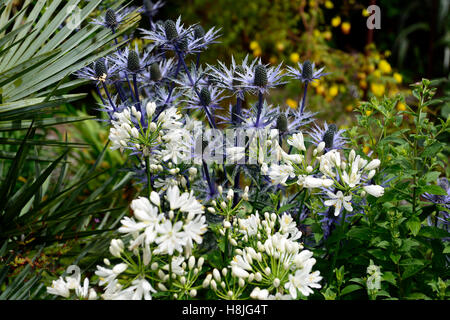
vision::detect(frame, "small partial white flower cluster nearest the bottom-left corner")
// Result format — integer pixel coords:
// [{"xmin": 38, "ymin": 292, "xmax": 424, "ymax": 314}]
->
[{"xmin": 47, "ymin": 265, "xmax": 97, "ymax": 300}]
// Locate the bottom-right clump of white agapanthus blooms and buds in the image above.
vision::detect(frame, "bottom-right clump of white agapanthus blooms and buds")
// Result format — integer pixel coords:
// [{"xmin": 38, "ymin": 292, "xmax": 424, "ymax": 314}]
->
[{"xmin": 203, "ymin": 212, "xmax": 322, "ymax": 299}]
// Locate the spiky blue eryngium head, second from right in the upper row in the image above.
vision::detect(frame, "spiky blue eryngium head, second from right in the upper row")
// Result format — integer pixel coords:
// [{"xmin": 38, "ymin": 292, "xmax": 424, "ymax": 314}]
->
[{"xmin": 235, "ymin": 59, "xmax": 286, "ymax": 94}]
